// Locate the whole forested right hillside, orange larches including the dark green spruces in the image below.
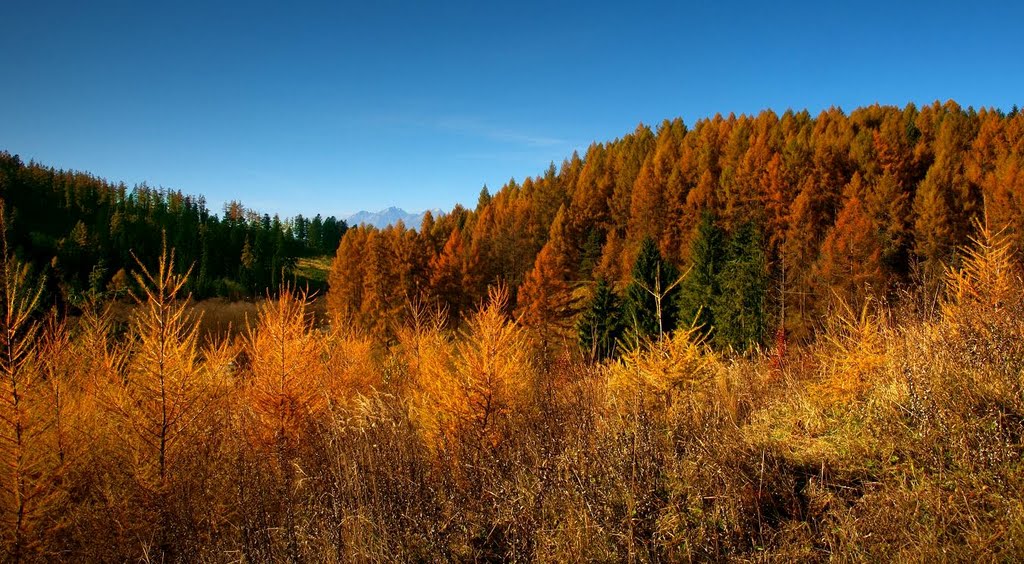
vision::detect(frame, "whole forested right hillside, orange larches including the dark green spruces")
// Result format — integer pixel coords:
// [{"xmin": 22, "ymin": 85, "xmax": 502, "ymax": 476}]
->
[{"xmin": 330, "ymin": 101, "xmax": 1024, "ymax": 351}]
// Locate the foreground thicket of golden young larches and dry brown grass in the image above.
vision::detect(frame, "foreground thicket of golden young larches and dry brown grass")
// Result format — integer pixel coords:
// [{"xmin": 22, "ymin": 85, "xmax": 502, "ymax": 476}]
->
[{"xmin": 0, "ymin": 200, "xmax": 1024, "ymax": 562}]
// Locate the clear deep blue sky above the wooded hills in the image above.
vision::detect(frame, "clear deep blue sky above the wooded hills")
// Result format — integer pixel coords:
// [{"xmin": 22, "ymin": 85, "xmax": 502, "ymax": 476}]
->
[{"xmin": 0, "ymin": 0, "xmax": 1024, "ymax": 215}]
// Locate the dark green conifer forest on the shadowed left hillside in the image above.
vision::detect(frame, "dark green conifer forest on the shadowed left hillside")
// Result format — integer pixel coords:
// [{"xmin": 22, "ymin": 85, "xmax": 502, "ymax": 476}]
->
[{"xmin": 0, "ymin": 153, "xmax": 347, "ymax": 305}]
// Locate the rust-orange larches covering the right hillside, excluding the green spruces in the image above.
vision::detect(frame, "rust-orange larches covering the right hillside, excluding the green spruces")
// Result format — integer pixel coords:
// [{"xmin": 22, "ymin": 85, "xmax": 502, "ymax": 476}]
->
[{"xmin": 330, "ymin": 101, "xmax": 1024, "ymax": 345}]
